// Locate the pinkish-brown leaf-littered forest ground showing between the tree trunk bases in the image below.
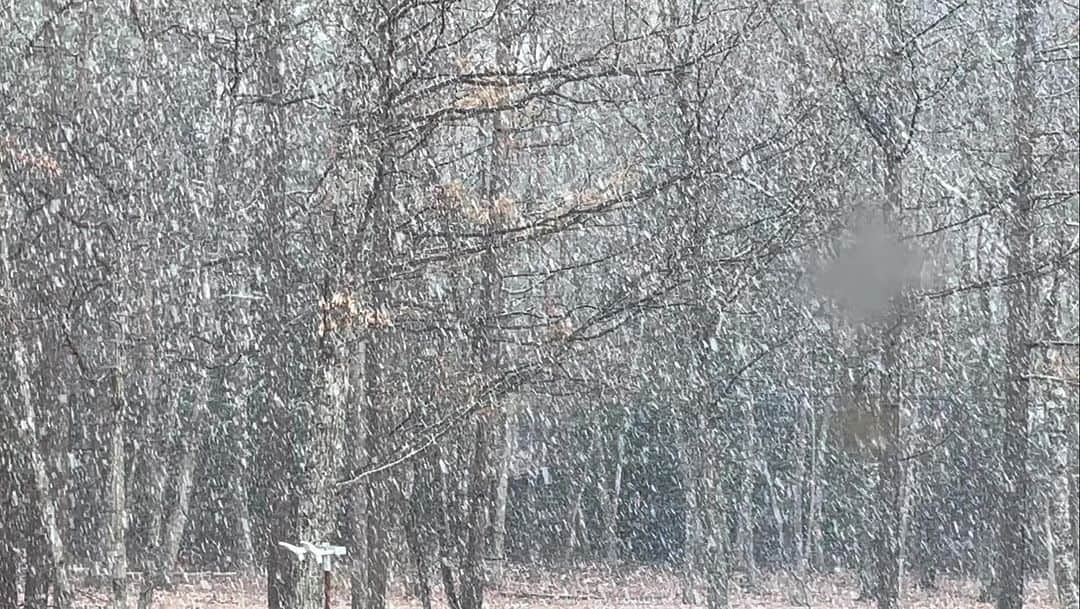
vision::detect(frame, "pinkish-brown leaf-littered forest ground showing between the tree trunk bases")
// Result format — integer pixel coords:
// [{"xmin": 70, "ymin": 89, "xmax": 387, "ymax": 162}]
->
[{"xmin": 76, "ymin": 567, "xmax": 1056, "ymax": 609}]
